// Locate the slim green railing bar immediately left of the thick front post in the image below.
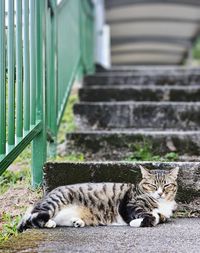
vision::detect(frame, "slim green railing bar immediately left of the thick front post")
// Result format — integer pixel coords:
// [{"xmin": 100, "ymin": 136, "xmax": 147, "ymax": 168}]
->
[{"xmin": 30, "ymin": 0, "xmax": 36, "ymax": 125}]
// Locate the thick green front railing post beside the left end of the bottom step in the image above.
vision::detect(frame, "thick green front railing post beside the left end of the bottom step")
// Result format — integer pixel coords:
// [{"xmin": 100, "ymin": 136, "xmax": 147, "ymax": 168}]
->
[{"xmin": 32, "ymin": 0, "xmax": 47, "ymax": 187}]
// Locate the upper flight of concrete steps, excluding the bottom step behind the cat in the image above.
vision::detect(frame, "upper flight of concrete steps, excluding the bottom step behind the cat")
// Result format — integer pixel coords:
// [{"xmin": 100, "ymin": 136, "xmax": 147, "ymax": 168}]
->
[{"xmin": 66, "ymin": 67, "xmax": 200, "ymax": 161}]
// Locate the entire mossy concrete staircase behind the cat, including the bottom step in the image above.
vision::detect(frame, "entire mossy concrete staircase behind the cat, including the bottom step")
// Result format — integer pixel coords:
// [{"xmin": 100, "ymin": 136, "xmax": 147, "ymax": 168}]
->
[{"xmin": 44, "ymin": 67, "xmax": 200, "ymax": 215}]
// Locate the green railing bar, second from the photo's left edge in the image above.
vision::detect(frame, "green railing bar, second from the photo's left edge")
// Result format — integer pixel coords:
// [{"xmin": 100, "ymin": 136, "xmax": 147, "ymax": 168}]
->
[{"xmin": 8, "ymin": 0, "xmax": 15, "ymax": 145}]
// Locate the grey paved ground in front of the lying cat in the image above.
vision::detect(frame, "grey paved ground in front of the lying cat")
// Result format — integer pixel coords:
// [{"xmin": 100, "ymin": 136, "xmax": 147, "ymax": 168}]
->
[{"xmin": 0, "ymin": 218, "xmax": 200, "ymax": 253}]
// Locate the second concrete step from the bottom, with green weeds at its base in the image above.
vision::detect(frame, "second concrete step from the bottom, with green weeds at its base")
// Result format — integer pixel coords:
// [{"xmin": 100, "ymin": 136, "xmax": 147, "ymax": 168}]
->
[{"xmin": 64, "ymin": 130, "xmax": 200, "ymax": 161}]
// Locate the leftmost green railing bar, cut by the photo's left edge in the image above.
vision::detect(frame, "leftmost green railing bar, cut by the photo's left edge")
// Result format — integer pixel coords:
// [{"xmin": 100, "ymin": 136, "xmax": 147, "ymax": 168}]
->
[{"xmin": 0, "ymin": 1, "xmax": 6, "ymax": 155}]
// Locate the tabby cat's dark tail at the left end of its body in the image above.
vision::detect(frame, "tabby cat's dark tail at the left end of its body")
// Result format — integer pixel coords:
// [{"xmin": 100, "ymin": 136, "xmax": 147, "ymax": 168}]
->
[{"xmin": 17, "ymin": 207, "xmax": 50, "ymax": 233}]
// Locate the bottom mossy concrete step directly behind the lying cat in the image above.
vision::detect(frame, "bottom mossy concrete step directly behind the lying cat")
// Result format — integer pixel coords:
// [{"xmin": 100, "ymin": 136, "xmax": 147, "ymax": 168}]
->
[{"xmin": 44, "ymin": 162, "xmax": 200, "ymax": 209}]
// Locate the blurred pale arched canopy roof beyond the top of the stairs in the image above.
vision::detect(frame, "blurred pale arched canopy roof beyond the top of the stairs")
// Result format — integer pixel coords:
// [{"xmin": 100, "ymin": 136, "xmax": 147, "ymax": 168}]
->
[{"xmin": 97, "ymin": 0, "xmax": 200, "ymax": 65}]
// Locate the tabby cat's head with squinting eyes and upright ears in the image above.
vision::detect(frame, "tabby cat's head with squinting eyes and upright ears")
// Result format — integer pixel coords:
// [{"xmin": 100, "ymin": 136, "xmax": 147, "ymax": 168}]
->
[{"xmin": 138, "ymin": 165, "xmax": 179, "ymax": 201}]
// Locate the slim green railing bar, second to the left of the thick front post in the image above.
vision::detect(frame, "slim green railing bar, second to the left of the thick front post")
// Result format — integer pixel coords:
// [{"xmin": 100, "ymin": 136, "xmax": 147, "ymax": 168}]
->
[{"xmin": 23, "ymin": 0, "xmax": 30, "ymax": 131}]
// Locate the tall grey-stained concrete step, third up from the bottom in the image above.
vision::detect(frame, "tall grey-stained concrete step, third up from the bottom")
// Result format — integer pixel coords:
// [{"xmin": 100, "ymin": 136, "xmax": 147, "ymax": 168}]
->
[{"xmin": 74, "ymin": 102, "xmax": 200, "ymax": 130}]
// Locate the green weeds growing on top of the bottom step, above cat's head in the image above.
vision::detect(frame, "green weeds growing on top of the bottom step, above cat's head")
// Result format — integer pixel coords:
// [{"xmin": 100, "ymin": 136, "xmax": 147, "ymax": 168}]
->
[{"xmin": 125, "ymin": 142, "xmax": 178, "ymax": 162}]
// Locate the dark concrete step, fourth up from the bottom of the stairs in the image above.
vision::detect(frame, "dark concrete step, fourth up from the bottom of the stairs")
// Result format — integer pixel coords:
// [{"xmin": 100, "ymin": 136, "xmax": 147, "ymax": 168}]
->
[{"xmin": 79, "ymin": 85, "xmax": 200, "ymax": 102}]
